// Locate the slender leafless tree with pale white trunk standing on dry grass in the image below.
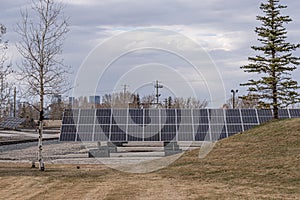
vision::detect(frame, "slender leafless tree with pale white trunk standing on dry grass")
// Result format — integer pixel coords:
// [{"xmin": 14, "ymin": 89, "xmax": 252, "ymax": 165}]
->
[{"xmin": 17, "ymin": 0, "xmax": 69, "ymax": 170}]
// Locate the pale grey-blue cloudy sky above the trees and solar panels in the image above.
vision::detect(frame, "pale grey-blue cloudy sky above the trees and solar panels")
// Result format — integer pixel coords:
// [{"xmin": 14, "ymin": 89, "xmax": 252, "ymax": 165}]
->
[{"xmin": 0, "ymin": 0, "xmax": 300, "ymax": 107}]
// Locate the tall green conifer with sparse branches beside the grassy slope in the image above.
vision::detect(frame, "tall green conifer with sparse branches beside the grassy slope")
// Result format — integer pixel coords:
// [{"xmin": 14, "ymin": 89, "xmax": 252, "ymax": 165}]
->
[{"xmin": 241, "ymin": 0, "xmax": 300, "ymax": 119}]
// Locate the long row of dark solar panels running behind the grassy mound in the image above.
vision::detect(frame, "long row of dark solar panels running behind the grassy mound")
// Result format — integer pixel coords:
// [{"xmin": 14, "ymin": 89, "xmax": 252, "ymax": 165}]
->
[{"xmin": 60, "ymin": 108, "xmax": 300, "ymax": 142}]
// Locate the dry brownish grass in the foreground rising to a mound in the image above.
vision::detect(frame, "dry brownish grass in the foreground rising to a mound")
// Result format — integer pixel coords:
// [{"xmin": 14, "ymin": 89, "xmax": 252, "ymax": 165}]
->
[{"xmin": 0, "ymin": 119, "xmax": 300, "ymax": 199}]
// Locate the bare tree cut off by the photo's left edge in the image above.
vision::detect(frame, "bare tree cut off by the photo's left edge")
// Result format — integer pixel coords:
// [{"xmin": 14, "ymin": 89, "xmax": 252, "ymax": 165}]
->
[{"xmin": 0, "ymin": 24, "xmax": 12, "ymax": 119}]
